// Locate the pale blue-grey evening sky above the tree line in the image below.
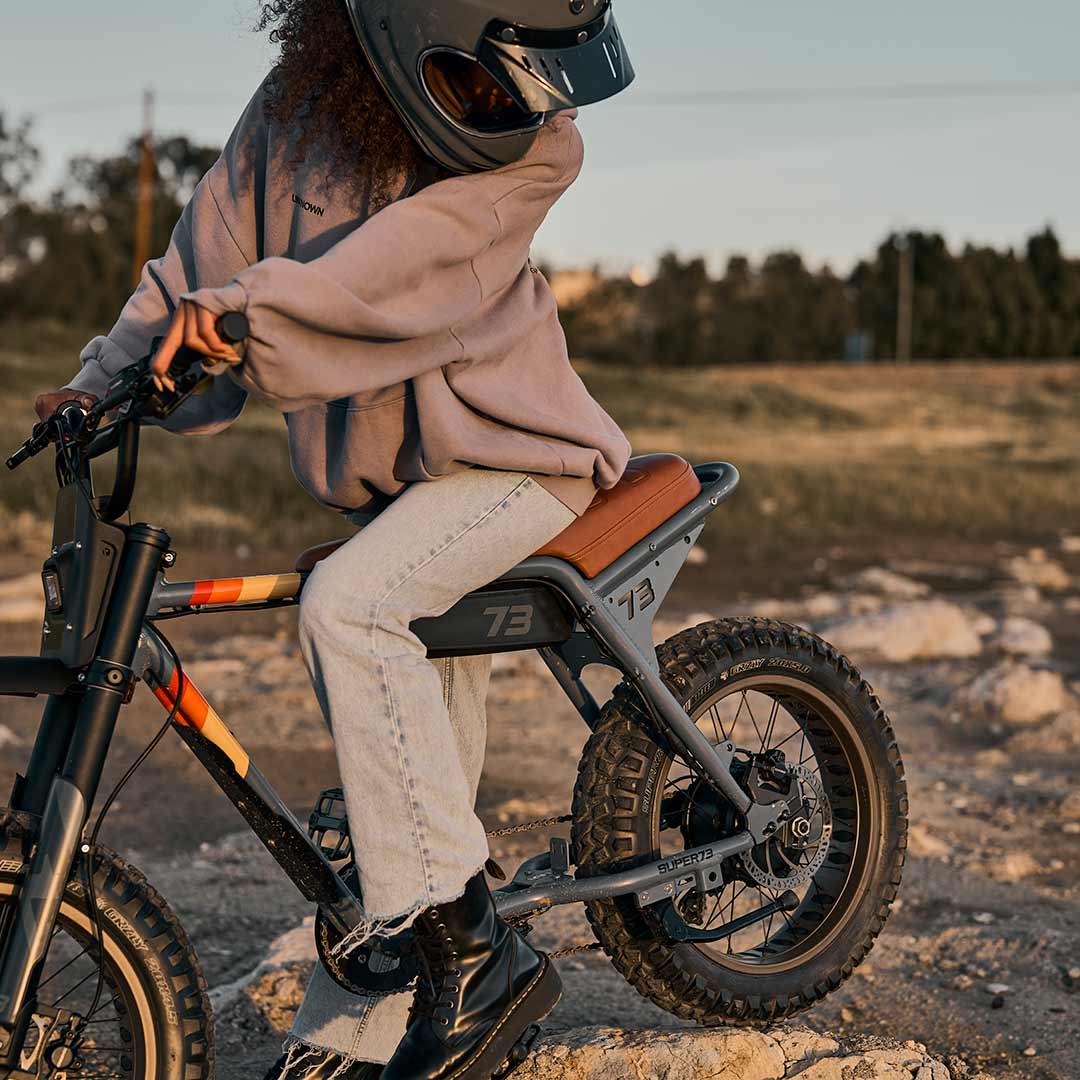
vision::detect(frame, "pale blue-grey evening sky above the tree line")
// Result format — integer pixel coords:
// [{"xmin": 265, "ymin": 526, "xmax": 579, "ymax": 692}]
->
[{"xmin": 0, "ymin": 0, "xmax": 1080, "ymax": 271}]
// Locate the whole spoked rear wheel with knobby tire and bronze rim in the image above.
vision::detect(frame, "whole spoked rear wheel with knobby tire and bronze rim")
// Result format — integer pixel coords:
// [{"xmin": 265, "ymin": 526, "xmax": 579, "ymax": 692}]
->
[{"xmin": 573, "ymin": 619, "xmax": 907, "ymax": 1024}]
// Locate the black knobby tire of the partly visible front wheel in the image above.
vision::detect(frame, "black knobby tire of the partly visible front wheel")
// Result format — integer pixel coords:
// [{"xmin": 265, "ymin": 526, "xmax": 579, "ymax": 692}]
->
[{"xmin": 0, "ymin": 809, "xmax": 215, "ymax": 1080}]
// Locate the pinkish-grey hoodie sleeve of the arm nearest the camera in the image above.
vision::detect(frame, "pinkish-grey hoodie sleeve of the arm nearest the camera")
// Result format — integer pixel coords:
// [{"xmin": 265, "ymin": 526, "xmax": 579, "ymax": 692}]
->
[{"xmin": 188, "ymin": 114, "xmax": 582, "ymax": 413}]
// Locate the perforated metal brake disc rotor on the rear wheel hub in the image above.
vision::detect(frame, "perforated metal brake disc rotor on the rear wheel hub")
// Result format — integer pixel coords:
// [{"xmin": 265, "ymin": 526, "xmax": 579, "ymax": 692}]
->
[{"xmin": 740, "ymin": 765, "xmax": 833, "ymax": 889}]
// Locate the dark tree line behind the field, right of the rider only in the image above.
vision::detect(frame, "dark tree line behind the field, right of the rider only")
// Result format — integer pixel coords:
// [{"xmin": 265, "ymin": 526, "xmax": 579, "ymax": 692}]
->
[{"xmin": 562, "ymin": 228, "xmax": 1080, "ymax": 366}]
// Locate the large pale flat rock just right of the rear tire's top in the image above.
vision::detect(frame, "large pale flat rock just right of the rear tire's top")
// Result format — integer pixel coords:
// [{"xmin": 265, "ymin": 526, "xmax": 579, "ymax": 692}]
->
[{"xmin": 821, "ymin": 599, "xmax": 983, "ymax": 663}]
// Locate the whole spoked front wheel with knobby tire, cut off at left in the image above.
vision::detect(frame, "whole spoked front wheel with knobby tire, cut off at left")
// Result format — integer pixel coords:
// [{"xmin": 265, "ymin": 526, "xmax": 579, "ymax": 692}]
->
[{"xmin": 0, "ymin": 809, "xmax": 214, "ymax": 1080}]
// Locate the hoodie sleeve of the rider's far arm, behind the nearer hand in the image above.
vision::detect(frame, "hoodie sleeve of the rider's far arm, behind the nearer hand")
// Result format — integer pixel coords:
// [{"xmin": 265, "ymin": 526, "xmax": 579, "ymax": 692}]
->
[{"xmin": 68, "ymin": 87, "xmax": 265, "ymax": 434}]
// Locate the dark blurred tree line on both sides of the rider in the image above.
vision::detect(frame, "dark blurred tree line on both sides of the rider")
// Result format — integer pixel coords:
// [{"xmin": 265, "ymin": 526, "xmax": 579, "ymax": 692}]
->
[{"xmin": 0, "ymin": 110, "xmax": 1080, "ymax": 366}]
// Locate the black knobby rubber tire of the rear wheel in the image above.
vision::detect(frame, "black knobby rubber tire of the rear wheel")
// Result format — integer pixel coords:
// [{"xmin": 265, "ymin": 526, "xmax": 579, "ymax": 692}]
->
[{"xmin": 572, "ymin": 618, "xmax": 907, "ymax": 1026}]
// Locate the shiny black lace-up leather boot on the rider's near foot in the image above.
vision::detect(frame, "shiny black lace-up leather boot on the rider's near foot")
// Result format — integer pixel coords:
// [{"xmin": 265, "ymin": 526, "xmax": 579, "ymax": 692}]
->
[{"xmin": 381, "ymin": 874, "xmax": 563, "ymax": 1080}]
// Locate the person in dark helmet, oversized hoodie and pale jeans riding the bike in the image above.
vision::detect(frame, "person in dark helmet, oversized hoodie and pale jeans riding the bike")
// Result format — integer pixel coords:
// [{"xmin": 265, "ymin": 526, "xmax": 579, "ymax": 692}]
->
[{"xmin": 37, "ymin": 0, "xmax": 633, "ymax": 1080}]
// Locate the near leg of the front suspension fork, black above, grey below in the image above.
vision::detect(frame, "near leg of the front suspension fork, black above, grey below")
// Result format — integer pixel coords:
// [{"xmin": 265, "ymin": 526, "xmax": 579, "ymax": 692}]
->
[{"xmin": 0, "ymin": 525, "xmax": 170, "ymax": 1067}]
